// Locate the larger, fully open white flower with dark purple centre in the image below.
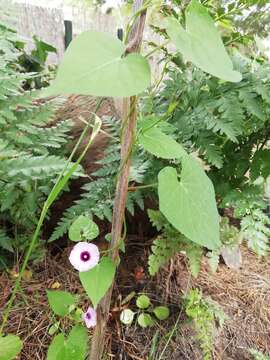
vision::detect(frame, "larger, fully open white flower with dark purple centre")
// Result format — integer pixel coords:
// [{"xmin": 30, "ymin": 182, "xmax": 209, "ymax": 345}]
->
[{"xmin": 69, "ymin": 241, "xmax": 99, "ymax": 272}]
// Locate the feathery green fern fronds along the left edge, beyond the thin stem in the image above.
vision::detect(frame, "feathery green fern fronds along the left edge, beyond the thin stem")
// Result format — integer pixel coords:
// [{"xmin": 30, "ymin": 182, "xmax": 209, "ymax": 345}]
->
[{"xmin": 0, "ymin": 24, "xmax": 75, "ymax": 262}]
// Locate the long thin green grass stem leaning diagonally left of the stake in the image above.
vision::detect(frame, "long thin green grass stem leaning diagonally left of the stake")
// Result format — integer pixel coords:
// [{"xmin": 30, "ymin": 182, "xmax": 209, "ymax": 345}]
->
[{"xmin": 0, "ymin": 98, "xmax": 104, "ymax": 335}]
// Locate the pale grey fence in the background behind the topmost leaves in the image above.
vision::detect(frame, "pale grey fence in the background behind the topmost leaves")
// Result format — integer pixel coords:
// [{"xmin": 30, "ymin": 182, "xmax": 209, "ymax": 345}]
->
[{"xmin": 5, "ymin": 0, "xmax": 162, "ymax": 77}]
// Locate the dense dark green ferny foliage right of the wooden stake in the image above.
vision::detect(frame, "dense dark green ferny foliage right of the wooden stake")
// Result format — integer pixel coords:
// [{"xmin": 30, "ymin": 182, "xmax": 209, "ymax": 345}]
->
[{"xmin": 142, "ymin": 55, "xmax": 270, "ymax": 255}]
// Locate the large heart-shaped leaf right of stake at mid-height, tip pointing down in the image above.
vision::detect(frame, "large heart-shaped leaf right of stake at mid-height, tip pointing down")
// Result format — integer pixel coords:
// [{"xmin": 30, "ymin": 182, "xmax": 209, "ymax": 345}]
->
[{"xmin": 158, "ymin": 155, "xmax": 220, "ymax": 249}]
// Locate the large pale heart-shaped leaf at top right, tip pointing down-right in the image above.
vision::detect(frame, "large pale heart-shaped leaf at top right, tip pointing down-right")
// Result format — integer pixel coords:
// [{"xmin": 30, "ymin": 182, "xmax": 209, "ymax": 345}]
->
[{"xmin": 165, "ymin": 0, "xmax": 242, "ymax": 82}]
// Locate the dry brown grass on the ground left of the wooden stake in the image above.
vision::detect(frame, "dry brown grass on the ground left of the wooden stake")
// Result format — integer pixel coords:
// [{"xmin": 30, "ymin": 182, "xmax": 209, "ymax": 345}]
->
[{"xmin": 0, "ymin": 250, "xmax": 88, "ymax": 360}]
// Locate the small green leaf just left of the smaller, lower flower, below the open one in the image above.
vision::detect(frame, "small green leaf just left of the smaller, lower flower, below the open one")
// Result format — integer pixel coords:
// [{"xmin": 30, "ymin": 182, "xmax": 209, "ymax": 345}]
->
[{"xmin": 47, "ymin": 290, "xmax": 76, "ymax": 316}]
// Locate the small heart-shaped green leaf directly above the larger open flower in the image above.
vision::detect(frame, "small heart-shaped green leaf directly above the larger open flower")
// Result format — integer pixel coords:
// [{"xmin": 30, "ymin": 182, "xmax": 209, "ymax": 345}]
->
[{"xmin": 68, "ymin": 215, "xmax": 99, "ymax": 241}]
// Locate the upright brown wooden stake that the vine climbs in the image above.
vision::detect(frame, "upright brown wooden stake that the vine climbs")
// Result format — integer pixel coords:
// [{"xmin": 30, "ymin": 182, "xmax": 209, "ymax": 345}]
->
[{"xmin": 89, "ymin": 0, "xmax": 147, "ymax": 360}]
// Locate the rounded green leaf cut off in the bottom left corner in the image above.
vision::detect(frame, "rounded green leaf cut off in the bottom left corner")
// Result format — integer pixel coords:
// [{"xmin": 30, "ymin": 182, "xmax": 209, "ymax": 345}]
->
[{"xmin": 0, "ymin": 334, "xmax": 23, "ymax": 360}]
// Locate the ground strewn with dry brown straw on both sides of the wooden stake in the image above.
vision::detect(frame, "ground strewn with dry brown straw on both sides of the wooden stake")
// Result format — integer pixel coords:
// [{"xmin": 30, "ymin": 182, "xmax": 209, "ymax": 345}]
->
[{"xmin": 0, "ymin": 236, "xmax": 270, "ymax": 360}]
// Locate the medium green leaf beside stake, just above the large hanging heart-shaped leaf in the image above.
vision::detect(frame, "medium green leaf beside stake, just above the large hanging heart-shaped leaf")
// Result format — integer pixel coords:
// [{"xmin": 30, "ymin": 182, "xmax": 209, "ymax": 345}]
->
[{"xmin": 138, "ymin": 127, "xmax": 185, "ymax": 159}]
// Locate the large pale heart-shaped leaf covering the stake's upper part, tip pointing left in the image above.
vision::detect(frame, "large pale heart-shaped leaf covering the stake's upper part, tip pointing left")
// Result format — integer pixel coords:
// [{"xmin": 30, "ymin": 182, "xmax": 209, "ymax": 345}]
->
[{"xmin": 44, "ymin": 31, "xmax": 151, "ymax": 97}]
